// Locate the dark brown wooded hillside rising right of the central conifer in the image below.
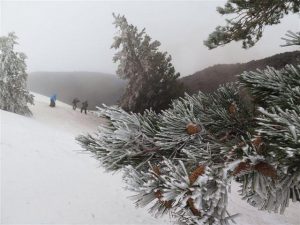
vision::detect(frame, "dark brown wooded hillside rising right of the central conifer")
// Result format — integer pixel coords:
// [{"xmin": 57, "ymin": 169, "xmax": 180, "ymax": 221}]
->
[{"xmin": 180, "ymin": 51, "xmax": 300, "ymax": 93}]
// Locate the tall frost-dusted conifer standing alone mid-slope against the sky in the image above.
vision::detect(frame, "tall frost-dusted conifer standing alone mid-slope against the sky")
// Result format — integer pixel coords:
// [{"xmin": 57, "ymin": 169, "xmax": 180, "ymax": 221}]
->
[{"xmin": 112, "ymin": 14, "xmax": 183, "ymax": 112}]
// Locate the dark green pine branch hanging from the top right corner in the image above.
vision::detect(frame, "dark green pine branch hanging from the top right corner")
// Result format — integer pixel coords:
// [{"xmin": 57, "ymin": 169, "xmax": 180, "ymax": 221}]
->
[{"xmin": 204, "ymin": 0, "xmax": 300, "ymax": 49}]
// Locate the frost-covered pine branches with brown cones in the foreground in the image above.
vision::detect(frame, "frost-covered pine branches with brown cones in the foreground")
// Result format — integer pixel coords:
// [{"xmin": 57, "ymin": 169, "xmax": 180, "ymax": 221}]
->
[{"xmin": 77, "ymin": 65, "xmax": 300, "ymax": 225}]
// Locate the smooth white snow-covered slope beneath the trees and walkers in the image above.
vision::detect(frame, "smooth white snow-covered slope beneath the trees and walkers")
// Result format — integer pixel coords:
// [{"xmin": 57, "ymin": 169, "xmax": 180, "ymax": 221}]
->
[{"xmin": 0, "ymin": 94, "xmax": 300, "ymax": 225}]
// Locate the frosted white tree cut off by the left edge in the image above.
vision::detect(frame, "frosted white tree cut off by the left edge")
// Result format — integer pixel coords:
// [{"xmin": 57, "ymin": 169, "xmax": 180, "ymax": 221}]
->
[{"xmin": 0, "ymin": 33, "xmax": 33, "ymax": 115}]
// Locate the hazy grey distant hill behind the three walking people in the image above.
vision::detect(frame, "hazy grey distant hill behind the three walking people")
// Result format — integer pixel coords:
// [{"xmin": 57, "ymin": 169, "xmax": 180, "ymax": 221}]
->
[{"xmin": 28, "ymin": 72, "xmax": 126, "ymax": 109}]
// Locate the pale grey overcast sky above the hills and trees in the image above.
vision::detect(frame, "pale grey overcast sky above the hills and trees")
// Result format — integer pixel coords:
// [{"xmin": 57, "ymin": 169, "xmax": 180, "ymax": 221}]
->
[{"xmin": 0, "ymin": 0, "xmax": 300, "ymax": 76}]
